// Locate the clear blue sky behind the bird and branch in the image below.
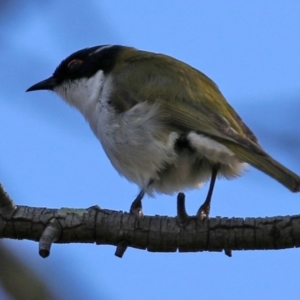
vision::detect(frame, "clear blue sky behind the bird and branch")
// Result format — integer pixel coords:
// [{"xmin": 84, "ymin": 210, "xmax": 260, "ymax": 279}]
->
[{"xmin": 0, "ymin": 0, "xmax": 300, "ymax": 300}]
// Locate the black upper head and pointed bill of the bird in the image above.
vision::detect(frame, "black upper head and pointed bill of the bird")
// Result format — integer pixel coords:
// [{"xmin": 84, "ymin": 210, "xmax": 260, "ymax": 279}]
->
[{"xmin": 26, "ymin": 45, "xmax": 124, "ymax": 92}]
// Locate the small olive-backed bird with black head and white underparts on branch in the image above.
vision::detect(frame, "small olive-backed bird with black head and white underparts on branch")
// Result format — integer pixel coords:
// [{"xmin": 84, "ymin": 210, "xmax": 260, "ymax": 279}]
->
[{"xmin": 27, "ymin": 45, "xmax": 300, "ymax": 219}]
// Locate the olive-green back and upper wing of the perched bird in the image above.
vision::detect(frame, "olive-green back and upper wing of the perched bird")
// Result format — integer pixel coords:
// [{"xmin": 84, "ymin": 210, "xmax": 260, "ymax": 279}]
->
[{"xmin": 114, "ymin": 49, "xmax": 257, "ymax": 143}]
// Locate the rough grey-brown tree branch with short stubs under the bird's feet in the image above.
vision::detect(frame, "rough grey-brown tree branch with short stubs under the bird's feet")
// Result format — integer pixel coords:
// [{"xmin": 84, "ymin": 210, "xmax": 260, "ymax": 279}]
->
[{"xmin": 0, "ymin": 185, "xmax": 300, "ymax": 257}]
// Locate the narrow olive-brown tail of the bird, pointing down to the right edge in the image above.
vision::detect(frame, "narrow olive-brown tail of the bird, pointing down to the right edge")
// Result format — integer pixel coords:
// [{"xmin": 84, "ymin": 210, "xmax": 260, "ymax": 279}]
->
[{"xmin": 226, "ymin": 144, "xmax": 300, "ymax": 192}]
